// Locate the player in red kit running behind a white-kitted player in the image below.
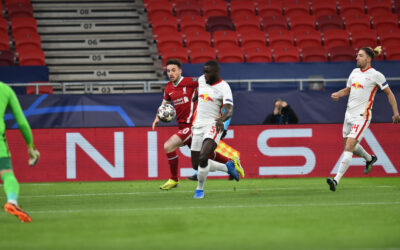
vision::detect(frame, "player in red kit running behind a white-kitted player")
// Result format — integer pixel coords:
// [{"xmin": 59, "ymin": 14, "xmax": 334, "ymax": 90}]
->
[{"xmin": 152, "ymin": 59, "xmax": 230, "ymax": 190}]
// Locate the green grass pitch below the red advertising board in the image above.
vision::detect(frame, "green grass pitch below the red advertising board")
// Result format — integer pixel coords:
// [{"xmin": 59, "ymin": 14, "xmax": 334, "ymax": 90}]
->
[{"xmin": 0, "ymin": 178, "xmax": 400, "ymax": 250}]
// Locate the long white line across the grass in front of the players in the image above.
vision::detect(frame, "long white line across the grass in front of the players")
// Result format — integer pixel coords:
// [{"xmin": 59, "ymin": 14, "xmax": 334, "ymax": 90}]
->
[{"xmin": 29, "ymin": 201, "xmax": 400, "ymax": 214}]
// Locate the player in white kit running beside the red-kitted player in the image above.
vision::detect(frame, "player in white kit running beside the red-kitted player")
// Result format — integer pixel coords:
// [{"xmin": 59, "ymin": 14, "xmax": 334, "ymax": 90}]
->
[{"xmin": 191, "ymin": 61, "xmax": 244, "ymax": 199}]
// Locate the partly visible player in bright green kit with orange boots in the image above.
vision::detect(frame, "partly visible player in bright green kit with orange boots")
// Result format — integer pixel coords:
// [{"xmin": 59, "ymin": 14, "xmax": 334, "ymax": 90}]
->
[{"xmin": 0, "ymin": 82, "xmax": 40, "ymax": 222}]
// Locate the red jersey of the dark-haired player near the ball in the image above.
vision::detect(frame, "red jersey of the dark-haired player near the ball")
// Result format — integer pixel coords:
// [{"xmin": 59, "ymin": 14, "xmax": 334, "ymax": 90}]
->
[{"xmin": 164, "ymin": 77, "xmax": 199, "ymax": 125}]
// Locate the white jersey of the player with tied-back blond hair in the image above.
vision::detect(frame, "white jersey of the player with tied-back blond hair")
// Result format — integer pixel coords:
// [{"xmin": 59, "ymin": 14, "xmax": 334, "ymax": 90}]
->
[{"xmin": 346, "ymin": 67, "xmax": 389, "ymax": 120}]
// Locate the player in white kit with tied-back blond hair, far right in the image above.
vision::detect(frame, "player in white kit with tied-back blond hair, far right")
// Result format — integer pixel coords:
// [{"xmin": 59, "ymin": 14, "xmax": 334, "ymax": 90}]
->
[{"xmin": 326, "ymin": 46, "xmax": 399, "ymax": 191}]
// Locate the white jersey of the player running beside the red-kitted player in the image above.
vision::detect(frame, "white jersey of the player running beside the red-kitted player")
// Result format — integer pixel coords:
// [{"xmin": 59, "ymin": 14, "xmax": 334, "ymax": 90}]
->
[{"xmin": 193, "ymin": 75, "xmax": 233, "ymax": 126}]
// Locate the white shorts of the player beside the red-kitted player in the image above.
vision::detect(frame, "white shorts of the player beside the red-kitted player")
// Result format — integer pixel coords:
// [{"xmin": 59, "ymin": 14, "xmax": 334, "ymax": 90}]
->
[{"xmin": 190, "ymin": 123, "xmax": 222, "ymax": 151}]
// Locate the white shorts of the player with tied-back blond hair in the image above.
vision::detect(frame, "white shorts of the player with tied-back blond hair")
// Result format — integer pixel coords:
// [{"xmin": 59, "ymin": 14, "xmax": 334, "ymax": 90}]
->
[{"xmin": 343, "ymin": 113, "xmax": 371, "ymax": 142}]
